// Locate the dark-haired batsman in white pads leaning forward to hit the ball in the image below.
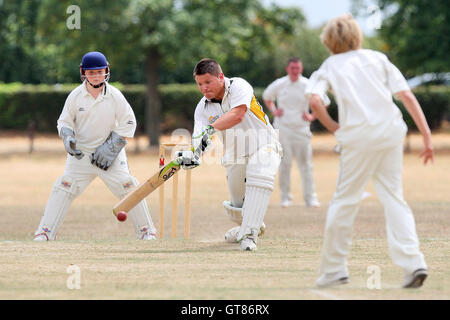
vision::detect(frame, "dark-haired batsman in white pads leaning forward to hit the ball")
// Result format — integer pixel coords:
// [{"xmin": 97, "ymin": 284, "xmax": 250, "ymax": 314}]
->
[{"xmin": 181, "ymin": 59, "xmax": 282, "ymax": 251}]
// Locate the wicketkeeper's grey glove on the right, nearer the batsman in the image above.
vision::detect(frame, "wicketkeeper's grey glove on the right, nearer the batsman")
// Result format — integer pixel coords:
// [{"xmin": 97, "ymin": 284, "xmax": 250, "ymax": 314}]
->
[{"xmin": 91, "ymin": 131, "xmax": 127, "ymax": 171}]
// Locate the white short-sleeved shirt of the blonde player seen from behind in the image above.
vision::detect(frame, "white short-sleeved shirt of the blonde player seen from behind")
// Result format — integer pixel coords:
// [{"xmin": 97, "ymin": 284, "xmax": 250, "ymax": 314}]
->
[{"xmin": 305, "ymin": 49, "xmax": 410, "ymax": 150}]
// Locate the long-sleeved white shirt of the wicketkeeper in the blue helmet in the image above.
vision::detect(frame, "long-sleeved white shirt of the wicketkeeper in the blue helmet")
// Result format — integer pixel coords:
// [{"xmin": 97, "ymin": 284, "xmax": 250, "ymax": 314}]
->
[{"xmin": 58, "ymin": 82, "xmax": 136, "ymax": 154}]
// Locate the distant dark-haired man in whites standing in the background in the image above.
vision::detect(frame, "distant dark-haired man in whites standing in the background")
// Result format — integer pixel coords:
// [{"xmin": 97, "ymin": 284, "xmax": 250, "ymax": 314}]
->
[{"xmin": 263, "ymin": 58, "xmax": 320, "ymax": 208}]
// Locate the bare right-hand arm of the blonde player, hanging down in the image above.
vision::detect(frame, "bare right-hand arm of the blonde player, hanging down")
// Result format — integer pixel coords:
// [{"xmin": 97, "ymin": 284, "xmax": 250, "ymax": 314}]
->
[{"xmin": 396, "ymin": 90, "xmax": 434, "ymax": 164}]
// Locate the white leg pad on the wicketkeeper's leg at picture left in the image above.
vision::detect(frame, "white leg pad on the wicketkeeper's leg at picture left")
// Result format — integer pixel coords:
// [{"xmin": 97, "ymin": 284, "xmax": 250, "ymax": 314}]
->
[{"xmin": 35, "ymin": 176, "xmax": 79, "ymax": 240}]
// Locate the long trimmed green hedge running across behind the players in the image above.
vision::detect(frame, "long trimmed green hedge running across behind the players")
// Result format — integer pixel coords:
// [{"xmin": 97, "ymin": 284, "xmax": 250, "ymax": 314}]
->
[{"xmin": 0, "ymin": 83, "xmax": 450, "ymax": 133}]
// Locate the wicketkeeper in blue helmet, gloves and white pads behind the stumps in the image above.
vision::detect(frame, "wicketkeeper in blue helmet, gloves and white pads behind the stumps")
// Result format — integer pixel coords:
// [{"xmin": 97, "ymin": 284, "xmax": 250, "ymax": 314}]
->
[{"xmin": 34, "ymin": 52, "xmax": 156, "ymax": 241}]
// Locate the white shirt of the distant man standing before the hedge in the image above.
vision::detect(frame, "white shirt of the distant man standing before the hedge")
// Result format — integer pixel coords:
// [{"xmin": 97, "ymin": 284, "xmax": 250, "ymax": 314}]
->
[{"xmin": 263, "ymin": 75, "xmax": 310, "ymax": 133}]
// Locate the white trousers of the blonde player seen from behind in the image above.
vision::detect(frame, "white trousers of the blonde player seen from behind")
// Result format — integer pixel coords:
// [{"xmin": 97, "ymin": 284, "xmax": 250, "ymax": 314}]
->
[{"xmin": 320, "ymin": 144, "xmax": 426, "ymax": 274}]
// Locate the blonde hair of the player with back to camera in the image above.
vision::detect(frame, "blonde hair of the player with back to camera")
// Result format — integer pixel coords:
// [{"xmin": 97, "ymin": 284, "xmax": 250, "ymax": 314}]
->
[{"xmin": 320, "ymin": 14, "xmax": 363, "ymax": 54}]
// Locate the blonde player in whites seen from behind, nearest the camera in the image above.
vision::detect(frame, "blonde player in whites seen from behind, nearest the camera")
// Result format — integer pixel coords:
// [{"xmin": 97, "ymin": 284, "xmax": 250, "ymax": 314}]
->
[{"xmin": 306, "ymin": 15, "xmax": 434, "ymax": 288}]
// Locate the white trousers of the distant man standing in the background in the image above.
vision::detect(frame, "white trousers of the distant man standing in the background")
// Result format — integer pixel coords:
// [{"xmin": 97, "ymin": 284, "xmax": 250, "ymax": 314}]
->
[{"xmin": 278, "ymin": 127, "xmax": 317, "ymax": 205}]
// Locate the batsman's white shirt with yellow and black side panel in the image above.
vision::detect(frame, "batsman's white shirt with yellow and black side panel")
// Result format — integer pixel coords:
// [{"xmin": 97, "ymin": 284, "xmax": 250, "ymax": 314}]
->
[{"xmin": 193, "ymin": 77, "xmax": 281, "ymax": 165}]
